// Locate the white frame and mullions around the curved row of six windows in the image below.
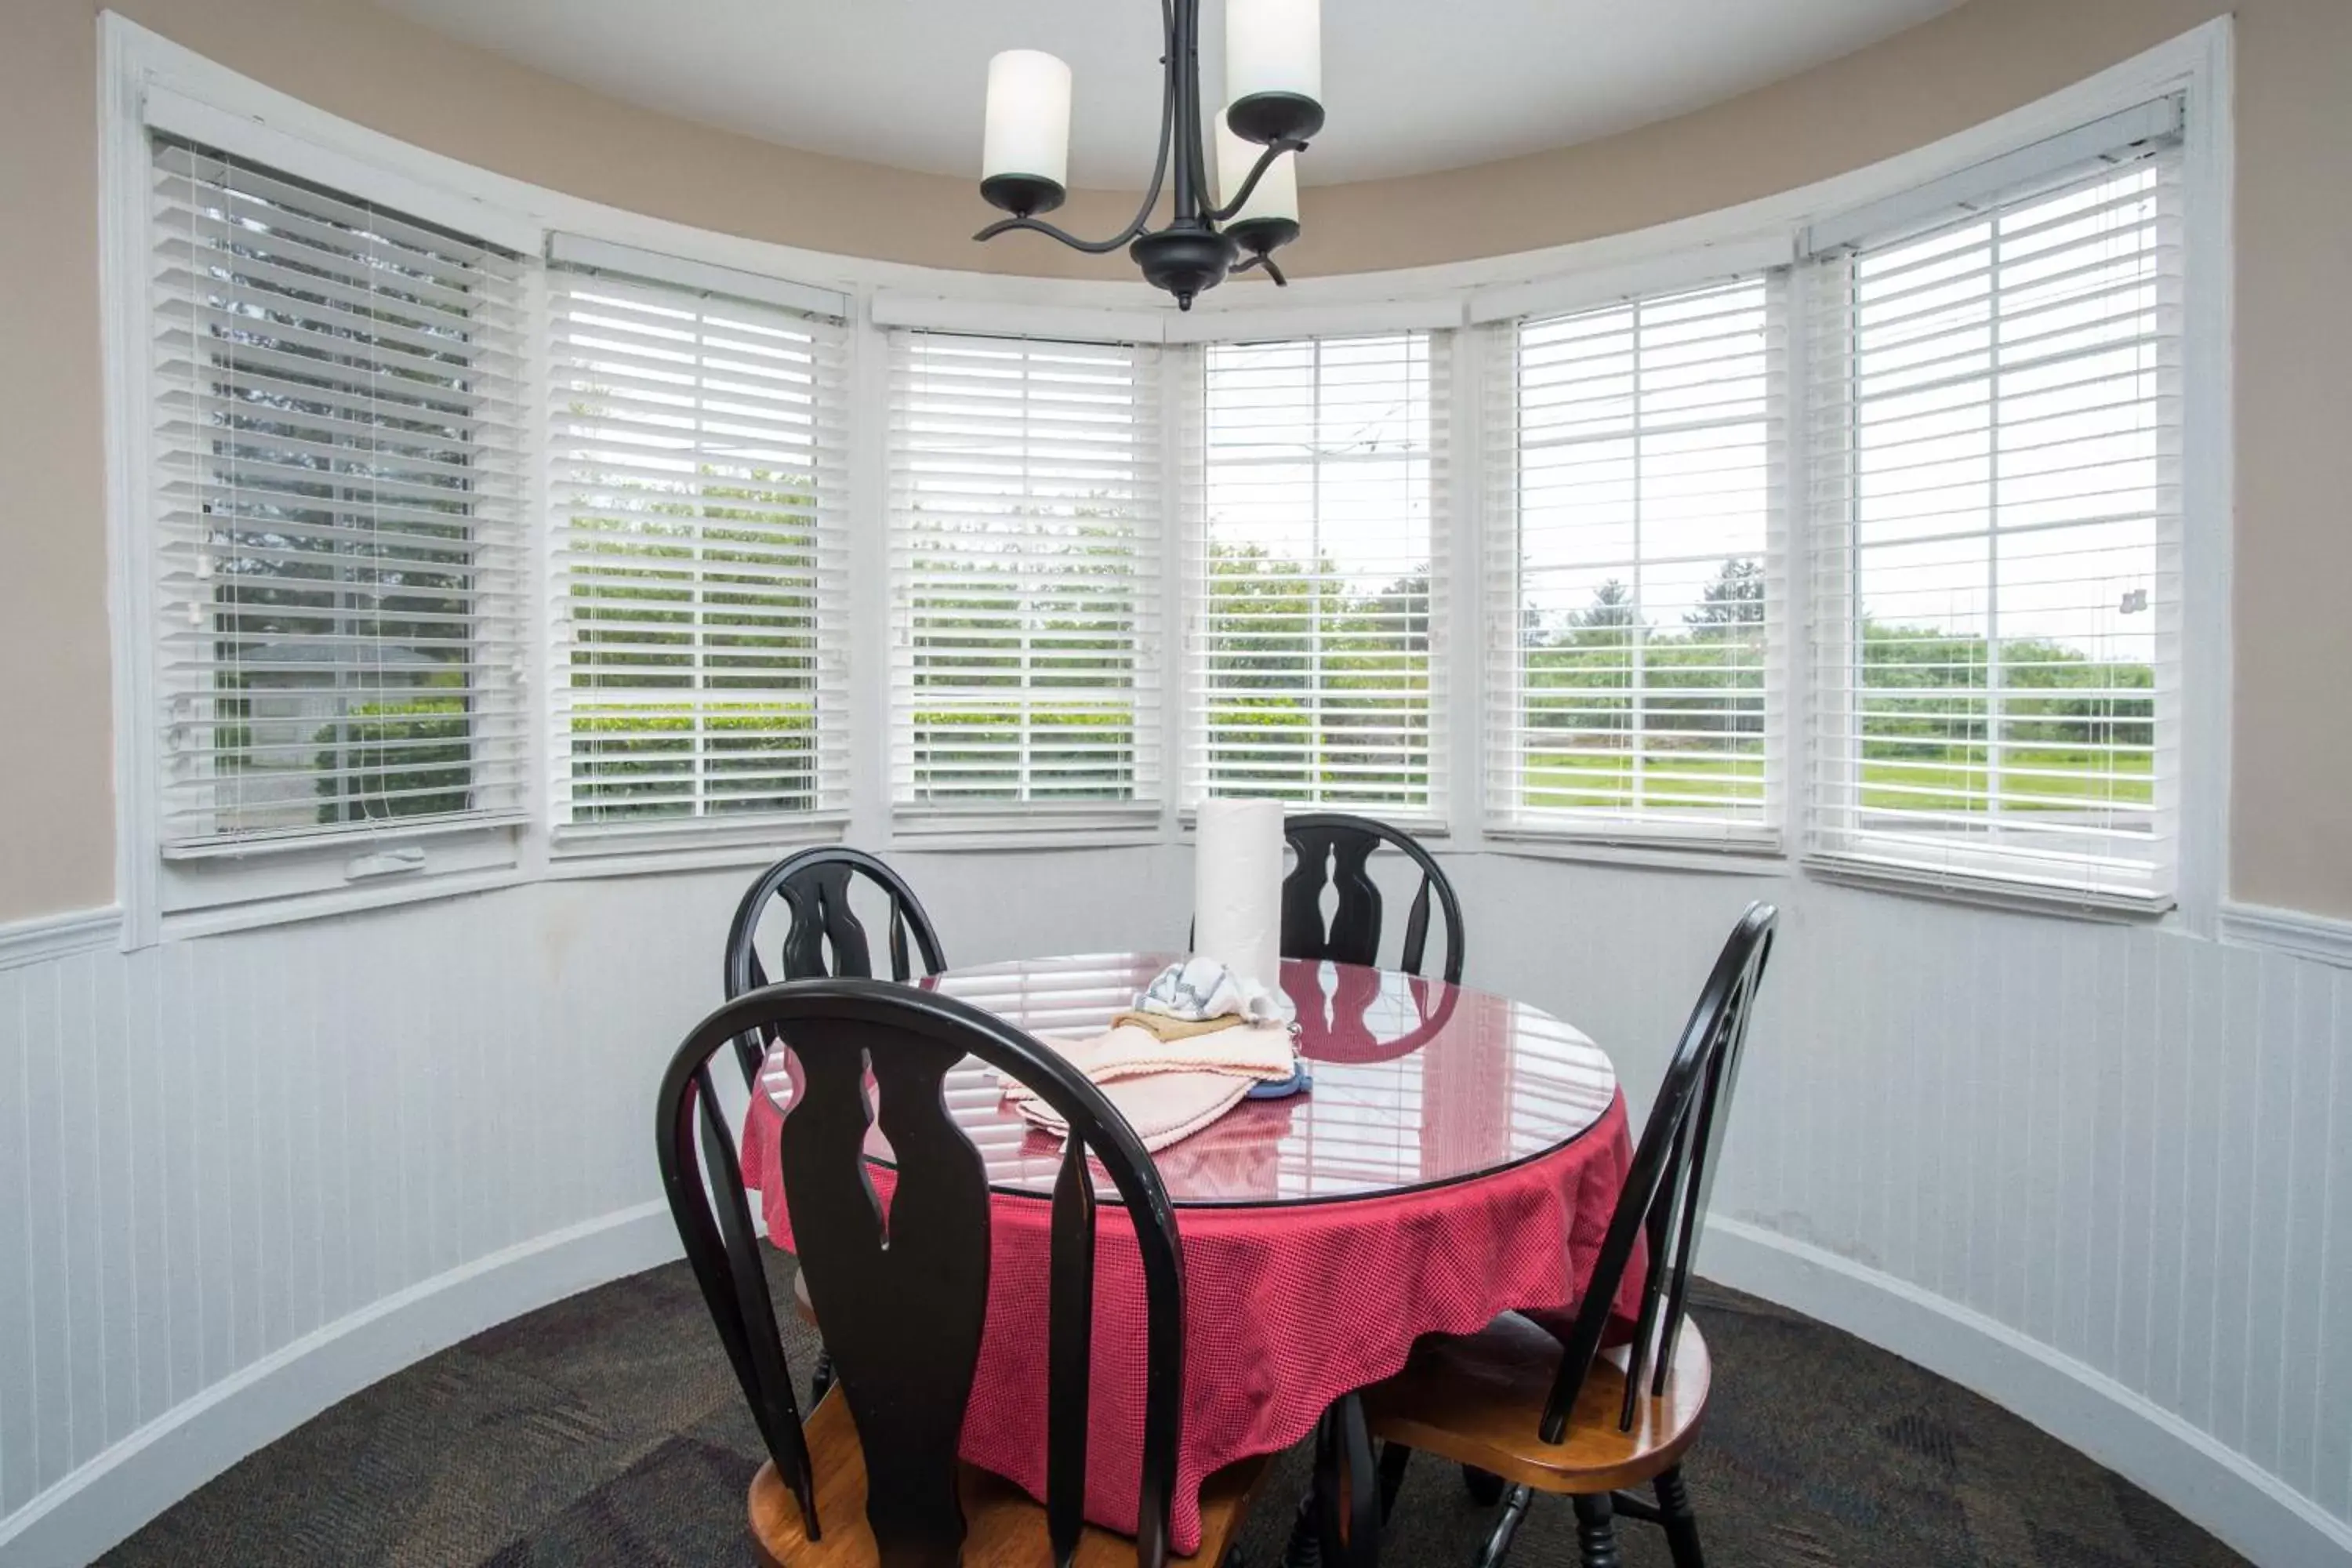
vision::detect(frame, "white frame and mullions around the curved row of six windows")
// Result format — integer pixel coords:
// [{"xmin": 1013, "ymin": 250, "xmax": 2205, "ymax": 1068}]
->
[{"xmin": 99, "ymin": 12, "xmax": 2234, "ymax": 947}]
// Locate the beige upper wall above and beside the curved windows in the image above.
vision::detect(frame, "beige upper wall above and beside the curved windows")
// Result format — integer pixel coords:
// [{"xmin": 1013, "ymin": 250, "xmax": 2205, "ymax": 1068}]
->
[{"xmin": 0, "ymin": 0, "xmax": 2352, "ymax": 919}]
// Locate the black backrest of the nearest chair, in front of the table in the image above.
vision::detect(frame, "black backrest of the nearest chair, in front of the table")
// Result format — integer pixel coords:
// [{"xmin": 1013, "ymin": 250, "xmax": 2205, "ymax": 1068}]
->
[{"xmin": 656, "ymin": 978, "xmax": 1183, "ymax": 1568}]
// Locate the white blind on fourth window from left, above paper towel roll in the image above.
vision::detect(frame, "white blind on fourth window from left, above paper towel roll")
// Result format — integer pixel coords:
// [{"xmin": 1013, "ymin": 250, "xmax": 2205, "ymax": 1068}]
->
[{"xmin": 1185, "ymin": 332, "xmax": 1451, "ymax": 818}]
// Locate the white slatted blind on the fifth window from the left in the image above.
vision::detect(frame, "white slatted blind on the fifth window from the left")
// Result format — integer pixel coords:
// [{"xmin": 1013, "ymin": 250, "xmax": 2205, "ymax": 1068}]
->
[{"xmin": 1486, "ymin": 275, "xmax": 1788, "ymax": 844}]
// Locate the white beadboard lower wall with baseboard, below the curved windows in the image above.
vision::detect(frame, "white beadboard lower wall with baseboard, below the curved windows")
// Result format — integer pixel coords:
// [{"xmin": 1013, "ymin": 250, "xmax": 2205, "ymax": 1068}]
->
[{"xmin": 0, "ymin": 846, "xmax": 2352, "ymax": 1568}]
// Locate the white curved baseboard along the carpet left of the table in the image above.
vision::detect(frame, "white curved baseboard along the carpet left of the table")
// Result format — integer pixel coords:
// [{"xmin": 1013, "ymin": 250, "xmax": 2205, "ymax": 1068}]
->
[{"xmin": 0, "ymin": 1201, "xmax": 680, "ymax": 1568}]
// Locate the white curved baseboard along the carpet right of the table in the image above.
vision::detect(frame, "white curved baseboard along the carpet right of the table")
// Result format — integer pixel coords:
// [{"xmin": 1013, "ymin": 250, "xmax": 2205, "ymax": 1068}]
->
[{"xmin": 1700, "ymin": 1215, "xmax": 2352, "ymax": 1568}]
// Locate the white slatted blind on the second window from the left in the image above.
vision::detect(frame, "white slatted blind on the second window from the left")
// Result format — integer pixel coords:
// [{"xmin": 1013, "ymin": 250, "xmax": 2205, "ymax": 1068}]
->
[{"xmin": 548, "ymin": 270, "xmax": 849, "ymax": 829}]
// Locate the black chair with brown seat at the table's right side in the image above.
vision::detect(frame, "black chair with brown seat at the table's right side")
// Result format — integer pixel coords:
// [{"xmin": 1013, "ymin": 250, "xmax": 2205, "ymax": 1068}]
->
[{"xmin": 1364, "ymin": 902, "xmax": 1778, "ymax": 1568}]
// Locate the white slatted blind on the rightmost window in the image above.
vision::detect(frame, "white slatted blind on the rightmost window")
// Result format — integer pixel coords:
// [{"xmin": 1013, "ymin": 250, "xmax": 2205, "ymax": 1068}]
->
[{"xmin": 1809, "ymin": 146, "xmax": 2180, "ymax": 902}]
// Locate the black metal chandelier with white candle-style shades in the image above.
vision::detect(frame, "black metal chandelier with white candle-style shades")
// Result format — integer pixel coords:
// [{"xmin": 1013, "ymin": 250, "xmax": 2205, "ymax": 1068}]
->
[{"xmin": 974, "ymin": 0, "xmax": 1322, "ymax": 310}]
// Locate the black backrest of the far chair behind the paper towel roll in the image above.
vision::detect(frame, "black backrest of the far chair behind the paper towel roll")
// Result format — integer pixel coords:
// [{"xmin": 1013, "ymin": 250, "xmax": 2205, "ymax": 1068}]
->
[{"xmin": 1282, "ymin": 811, "xmax": 1463, "ymax": 985}]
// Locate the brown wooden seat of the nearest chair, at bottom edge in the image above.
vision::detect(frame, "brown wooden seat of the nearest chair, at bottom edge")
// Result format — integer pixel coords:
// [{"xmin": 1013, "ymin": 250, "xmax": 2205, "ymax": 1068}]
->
[{"xmin": 750, "ymin": 1389, "xmax": 1272, "ymax": 1568}]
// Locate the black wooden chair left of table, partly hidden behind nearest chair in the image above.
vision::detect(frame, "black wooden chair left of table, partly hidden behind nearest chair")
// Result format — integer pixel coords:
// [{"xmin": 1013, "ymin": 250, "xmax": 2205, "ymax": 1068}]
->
[{"xmin": 727, "ymin": 844, "xmax": 948, "ymax": 1401}]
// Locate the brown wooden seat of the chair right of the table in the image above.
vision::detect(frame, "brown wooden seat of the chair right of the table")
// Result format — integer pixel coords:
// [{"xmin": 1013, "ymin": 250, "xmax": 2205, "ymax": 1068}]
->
[{"xmin": 1364, "ymin": 1312, "xmax": 1712, "ymax": 1495}]
